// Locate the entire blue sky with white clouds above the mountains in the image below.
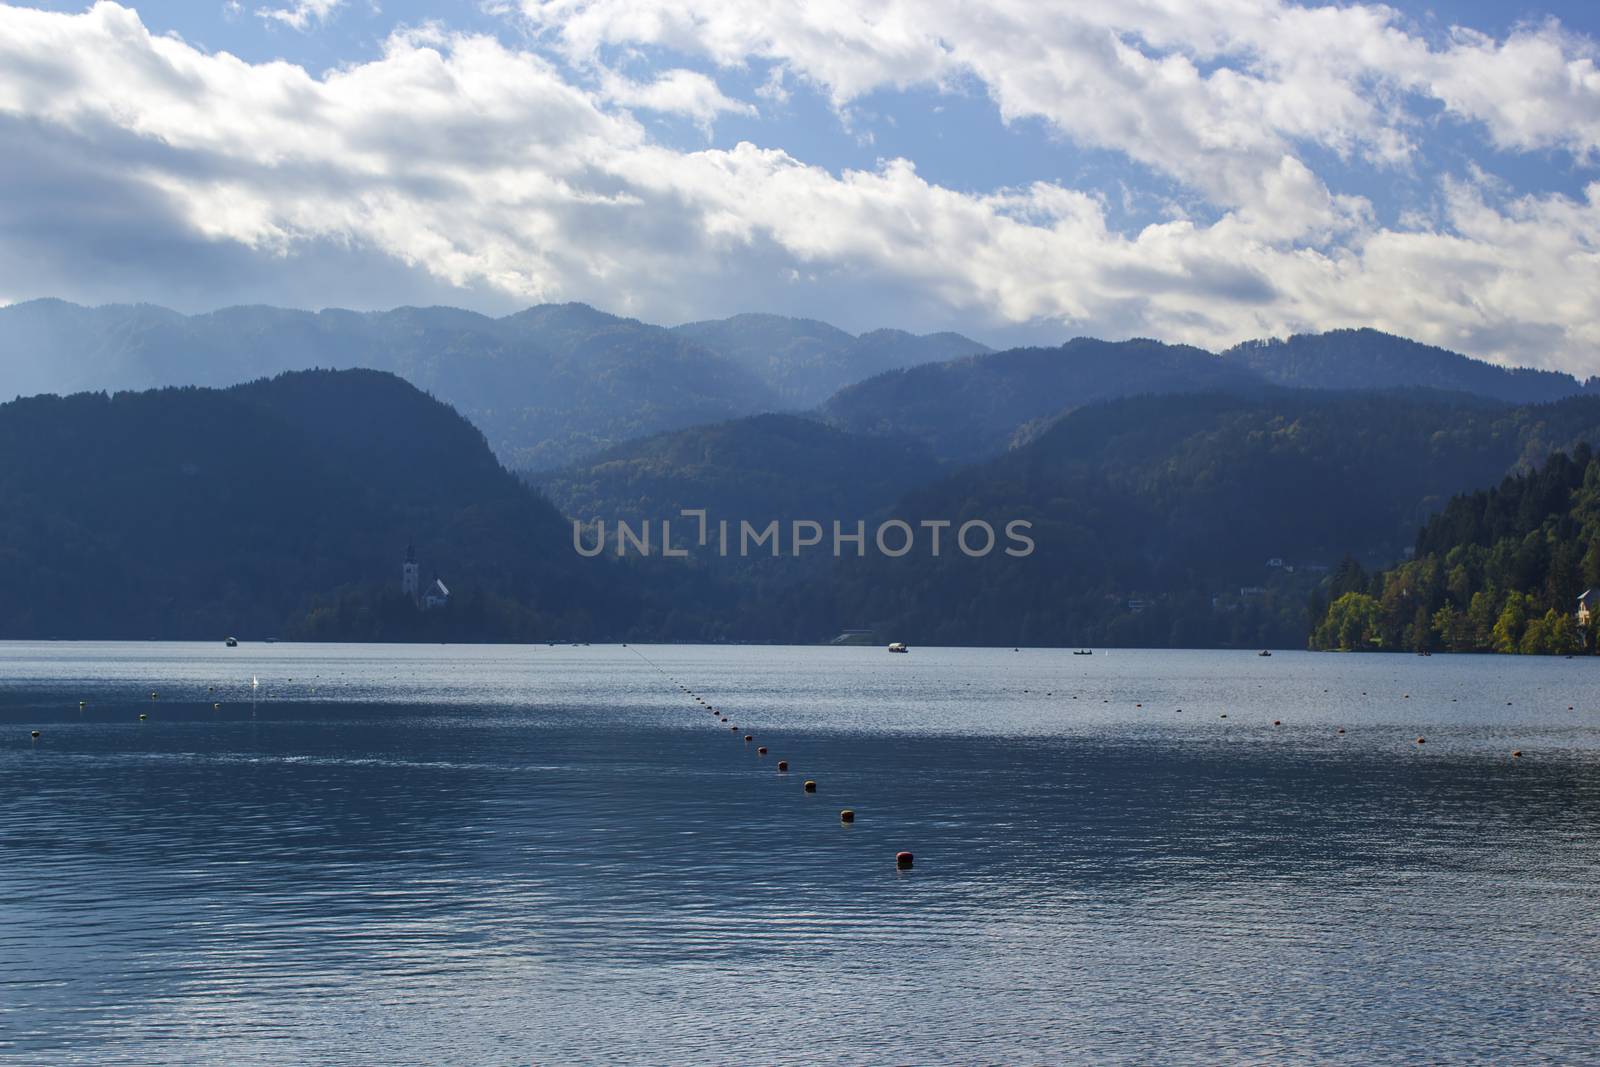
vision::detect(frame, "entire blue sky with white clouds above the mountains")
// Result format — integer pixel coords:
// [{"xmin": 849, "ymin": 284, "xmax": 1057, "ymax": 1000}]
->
[{"xmin": 0, "ymin": 0, "xmax": 1600, "ymax": 367}]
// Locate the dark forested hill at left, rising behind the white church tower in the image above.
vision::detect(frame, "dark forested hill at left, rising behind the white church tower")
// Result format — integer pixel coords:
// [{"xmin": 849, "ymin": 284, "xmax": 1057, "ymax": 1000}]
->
[{"xmin": 0, "ymin": 371, "xmax": 634, "ymax": 640}]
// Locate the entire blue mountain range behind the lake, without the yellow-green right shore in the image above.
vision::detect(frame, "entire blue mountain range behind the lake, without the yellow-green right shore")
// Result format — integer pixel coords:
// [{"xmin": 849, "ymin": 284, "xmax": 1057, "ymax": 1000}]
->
[{"xmin": 9, "ymin": 301, "xmax": 1600, "ymax": 645}]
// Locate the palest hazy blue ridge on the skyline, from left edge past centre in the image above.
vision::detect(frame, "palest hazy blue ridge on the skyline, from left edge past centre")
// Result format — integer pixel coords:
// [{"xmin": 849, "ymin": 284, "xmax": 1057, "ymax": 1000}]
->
[{"xmin": 0, "ymin": 299, "xmax": 986, "ymax": 469}]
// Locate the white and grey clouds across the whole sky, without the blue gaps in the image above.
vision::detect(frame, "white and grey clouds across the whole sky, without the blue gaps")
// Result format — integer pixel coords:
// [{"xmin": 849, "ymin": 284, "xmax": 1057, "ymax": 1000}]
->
[{"xmin": 0, "ymin": 0, "xmax": 1600, "ymax": 371}]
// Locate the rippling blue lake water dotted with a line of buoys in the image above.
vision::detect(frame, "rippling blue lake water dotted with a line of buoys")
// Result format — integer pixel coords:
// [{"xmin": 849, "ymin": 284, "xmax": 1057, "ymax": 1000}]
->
[{"xmin": 0, "ymin": 643, "xmax": 1600, "ymax": 1065}]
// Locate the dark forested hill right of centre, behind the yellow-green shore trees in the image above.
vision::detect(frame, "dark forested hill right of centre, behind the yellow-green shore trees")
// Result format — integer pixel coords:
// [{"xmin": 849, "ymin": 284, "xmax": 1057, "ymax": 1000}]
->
[{"xmin": 789, "ymin": 390, "xmax": 1600, "ymax": 646}]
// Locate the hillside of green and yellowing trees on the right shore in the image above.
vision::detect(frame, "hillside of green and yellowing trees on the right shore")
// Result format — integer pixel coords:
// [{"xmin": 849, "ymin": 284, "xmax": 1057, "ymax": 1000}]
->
[{"xmin": 1312, "ymin": 447, "xmax": 1600, "ymax": 653}]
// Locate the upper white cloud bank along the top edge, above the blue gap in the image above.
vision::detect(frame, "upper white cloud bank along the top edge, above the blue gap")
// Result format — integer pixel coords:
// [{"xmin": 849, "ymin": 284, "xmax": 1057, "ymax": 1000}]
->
[{"xmin": 520, "ymin": 0, "xmax": 1600, "ymax": 206}]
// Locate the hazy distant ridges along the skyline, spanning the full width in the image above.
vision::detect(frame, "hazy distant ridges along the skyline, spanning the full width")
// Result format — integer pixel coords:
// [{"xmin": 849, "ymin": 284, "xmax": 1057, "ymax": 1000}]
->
[{"xmin": 0, "ymin": 299, "xmax": 1600, "ymax": 472}]
